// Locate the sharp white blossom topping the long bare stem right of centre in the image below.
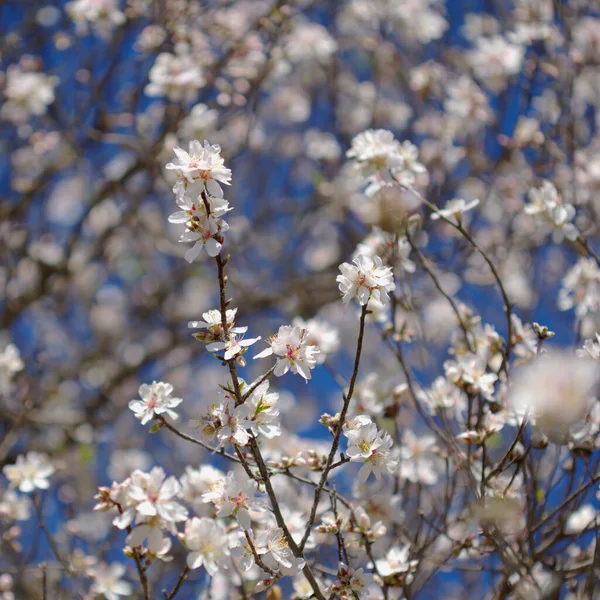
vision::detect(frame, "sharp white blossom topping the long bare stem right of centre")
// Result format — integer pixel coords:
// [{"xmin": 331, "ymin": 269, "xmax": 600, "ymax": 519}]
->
[{"xmin": 336, "ymin": 255, "xmax": 396, "ymax": 306}]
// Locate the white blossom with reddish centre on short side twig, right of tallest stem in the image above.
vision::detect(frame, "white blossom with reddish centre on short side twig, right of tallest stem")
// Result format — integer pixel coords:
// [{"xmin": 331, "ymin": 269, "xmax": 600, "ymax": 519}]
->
[{"xmin": 254, "ymin": 325, "xmax": 319, "ymax": 381}]
